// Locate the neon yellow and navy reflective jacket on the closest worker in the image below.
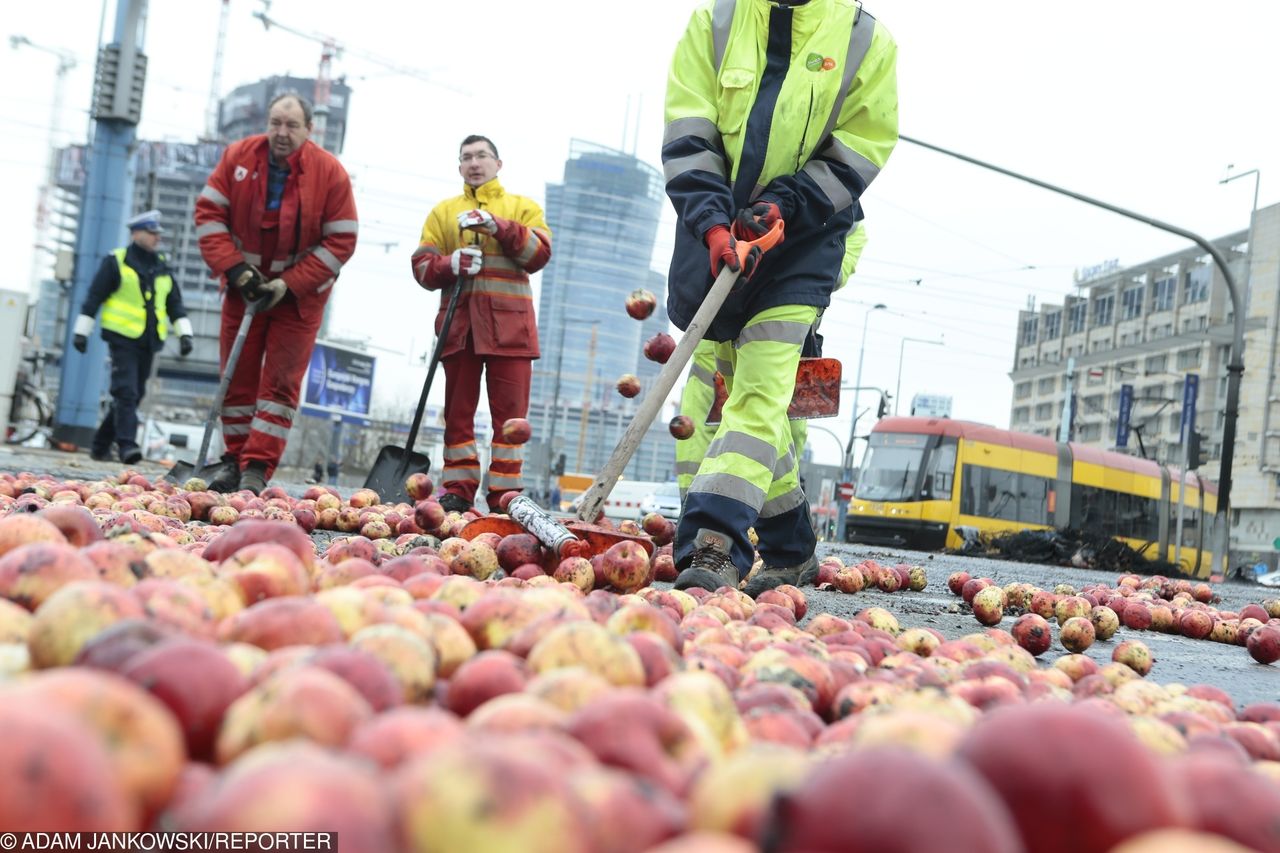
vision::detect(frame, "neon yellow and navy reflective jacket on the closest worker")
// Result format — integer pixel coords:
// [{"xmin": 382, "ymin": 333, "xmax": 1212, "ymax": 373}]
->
[{"xmin": 662, "ymin": 0, "xmax": 897, "ymax": 341}]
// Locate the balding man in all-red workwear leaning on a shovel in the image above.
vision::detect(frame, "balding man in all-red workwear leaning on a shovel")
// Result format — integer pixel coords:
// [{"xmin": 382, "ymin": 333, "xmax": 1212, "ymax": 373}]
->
[{"xmin": 196, "ymin": 92, "xmax": 357, "ymax": 493}]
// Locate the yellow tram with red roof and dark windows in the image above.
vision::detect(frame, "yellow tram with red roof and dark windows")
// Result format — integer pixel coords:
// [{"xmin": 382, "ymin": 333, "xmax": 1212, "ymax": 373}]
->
[{"xmin": 846, "ymin": 418, "xmax": 1217, "ymax": 576}]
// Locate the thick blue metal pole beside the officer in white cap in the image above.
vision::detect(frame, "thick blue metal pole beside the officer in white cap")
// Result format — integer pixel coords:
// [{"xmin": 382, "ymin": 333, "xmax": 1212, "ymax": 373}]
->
[{"xmin": 54, "ymin": 0, "xmax": 146, "ymax": 447}]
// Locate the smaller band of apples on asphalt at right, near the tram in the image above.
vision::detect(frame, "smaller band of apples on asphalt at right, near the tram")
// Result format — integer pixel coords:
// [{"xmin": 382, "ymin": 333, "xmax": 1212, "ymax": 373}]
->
[{"xmin": 947, "ymin": 571, "xmax": 1280, "ymax": 663}]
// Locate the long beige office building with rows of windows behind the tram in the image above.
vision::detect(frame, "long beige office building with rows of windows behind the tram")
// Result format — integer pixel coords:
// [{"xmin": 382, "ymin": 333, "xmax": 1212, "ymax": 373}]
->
[{"xmin": 1009, "ymin": 205, "xmax": 1280, "ymax": 566}]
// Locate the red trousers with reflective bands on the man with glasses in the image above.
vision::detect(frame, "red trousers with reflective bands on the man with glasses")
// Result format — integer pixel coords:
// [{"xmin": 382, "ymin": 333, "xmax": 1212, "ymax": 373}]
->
[{"xmin": 440, "ymin": 334, "xmax": 534, "ymax": 511}]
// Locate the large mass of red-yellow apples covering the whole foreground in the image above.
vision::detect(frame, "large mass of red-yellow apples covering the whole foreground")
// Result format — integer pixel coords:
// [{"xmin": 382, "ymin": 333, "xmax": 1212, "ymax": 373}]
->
[{"xmin": 0, "ymin": 475, "xmax": 1280, "ymax": 853}]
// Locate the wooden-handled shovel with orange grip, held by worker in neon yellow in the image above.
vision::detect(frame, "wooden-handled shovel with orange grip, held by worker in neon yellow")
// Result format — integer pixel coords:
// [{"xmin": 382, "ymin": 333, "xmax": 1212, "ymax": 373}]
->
[{"xmin": 460, "ymin": 220, "xmax": 782, "ymax": 560}]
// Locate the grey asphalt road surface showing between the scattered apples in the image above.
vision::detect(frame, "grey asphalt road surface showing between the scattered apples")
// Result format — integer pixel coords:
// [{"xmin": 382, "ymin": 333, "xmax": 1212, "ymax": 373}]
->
[{"xmin": 10, "ymin": 447, "xmax": 1280, "ymax": 706}]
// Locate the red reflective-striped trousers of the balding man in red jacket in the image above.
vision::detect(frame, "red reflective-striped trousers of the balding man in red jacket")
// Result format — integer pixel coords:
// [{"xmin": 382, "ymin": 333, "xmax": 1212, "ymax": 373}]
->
[{"xmin": 219, "ymin": 293, "xmax": 323, "ymax": 478}]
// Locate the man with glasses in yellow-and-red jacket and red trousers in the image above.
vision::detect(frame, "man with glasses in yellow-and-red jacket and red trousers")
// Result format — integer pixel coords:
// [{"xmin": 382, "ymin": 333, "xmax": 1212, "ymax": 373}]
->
[{"xmin": 412, "ymin": 136, "xmax": 552, "ymax": 512}]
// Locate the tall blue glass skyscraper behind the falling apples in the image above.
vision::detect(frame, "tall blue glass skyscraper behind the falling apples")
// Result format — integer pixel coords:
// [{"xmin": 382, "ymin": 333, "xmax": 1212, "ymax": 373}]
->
[{"xmin": 525, "ymin": 140, "xmax": 675, "ymax": 484}]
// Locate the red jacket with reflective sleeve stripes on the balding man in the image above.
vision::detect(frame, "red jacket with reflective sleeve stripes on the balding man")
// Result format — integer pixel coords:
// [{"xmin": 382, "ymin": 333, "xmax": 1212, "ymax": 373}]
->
[{"xmin": 196, "ymin": 133, "xmax": 358, "ymax": 320}]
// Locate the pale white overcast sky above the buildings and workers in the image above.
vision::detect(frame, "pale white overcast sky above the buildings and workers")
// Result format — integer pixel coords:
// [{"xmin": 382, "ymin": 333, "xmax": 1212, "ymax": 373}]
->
[{"xmin": 0, "ymin": 0, "xmax": 1280, "ymax": 461}]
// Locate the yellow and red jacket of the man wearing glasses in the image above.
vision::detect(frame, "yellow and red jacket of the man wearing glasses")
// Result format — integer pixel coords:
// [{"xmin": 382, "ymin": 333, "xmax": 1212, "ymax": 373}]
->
[{"xmin": 412, "ymin": 178, "xmax": 552, "ymax": 359}]
